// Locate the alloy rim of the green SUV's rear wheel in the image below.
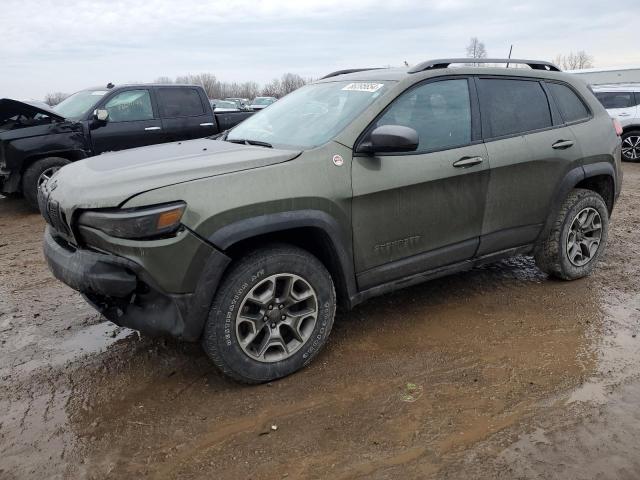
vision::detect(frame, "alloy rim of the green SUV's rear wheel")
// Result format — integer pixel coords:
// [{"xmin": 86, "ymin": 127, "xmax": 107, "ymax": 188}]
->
[{"xmin": 567, "ymin": 207, "xmax": 602, "ymax": 267}]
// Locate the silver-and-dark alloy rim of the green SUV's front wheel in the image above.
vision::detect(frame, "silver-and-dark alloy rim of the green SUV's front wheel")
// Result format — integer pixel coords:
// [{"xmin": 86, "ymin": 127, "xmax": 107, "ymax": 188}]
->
[{"xmin": 235, "ymin": 273, "xmax": 318, "ymax": 363}]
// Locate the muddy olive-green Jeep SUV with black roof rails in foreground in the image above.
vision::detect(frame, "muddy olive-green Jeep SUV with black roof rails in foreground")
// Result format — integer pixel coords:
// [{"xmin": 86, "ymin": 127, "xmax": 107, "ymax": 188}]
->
[{"xmin": 40, "ymin": 59, "xmax": 622, "ymax": 383}]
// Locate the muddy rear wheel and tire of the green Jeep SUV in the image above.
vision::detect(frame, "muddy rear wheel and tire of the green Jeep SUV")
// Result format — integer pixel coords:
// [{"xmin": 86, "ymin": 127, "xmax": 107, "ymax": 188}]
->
[{"xmin": 534, "ymin": 188, "xmax": 609, "ymax": 280}]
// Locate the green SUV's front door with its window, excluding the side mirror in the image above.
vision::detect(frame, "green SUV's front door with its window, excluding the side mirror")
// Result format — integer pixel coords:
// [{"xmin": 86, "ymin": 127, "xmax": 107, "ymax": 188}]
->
[{"xmin": 352, "ymin": 77, "xmax": 489, "ymax": 290}]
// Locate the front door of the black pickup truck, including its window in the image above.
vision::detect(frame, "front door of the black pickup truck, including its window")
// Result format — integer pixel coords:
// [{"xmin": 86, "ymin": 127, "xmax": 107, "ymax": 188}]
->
[{"xmin": 90, "ymin": 88, "xmax": 162, "ymax": 155}]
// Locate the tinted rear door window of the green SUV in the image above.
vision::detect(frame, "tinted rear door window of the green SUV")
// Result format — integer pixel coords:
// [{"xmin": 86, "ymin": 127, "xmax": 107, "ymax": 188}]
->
[{"xmin": 478, "ymin": 79, "xmax": 551, "ymax": 137}]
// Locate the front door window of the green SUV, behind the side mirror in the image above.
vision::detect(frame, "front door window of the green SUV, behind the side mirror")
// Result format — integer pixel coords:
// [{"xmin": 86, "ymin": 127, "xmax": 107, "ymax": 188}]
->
[{"xmin": 376, "ymin": 79, "xmax": 471, "ymax": 152}]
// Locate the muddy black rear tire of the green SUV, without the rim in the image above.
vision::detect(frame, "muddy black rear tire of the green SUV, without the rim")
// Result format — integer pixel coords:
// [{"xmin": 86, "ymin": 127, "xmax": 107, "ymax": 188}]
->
[{"xmin": 534, "ymin": 188, "xmax": 609, "ymax": 280}]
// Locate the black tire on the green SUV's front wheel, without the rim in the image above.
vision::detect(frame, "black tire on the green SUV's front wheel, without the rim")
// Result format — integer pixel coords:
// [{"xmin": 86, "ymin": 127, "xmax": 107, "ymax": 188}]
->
[{"xmin": 202, "ymin": 244, "xmax": 336, "ymax": 383}]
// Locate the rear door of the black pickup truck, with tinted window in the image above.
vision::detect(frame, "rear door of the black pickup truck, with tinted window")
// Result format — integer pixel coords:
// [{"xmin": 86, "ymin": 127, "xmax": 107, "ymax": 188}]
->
[{"xmin": 156, "ymin": 86, "xmax": 217, "ymax": 142}]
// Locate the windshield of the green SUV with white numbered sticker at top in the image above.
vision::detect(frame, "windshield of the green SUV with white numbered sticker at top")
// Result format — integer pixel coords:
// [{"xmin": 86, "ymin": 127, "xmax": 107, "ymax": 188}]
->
[{"xmin": 227, "ymin": 81, "xmax": 390, "ymax": 149}]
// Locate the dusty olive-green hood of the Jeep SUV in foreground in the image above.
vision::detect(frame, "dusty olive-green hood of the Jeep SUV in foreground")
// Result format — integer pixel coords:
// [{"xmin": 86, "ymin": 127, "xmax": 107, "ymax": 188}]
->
[{"xmin": 46, "ymin": 138, "xmax": 300, "ymax": 210}]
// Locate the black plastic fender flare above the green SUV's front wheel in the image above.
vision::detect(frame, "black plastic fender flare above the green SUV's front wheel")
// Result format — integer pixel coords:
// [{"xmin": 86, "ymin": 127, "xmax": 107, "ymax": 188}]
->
[{"xmin": 208, "ymin": 209, "xmax": 357, "ymax": 307}]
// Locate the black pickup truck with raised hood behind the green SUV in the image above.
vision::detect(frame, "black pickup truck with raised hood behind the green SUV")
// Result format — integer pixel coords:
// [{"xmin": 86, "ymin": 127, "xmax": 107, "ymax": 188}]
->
[{"xmin": 0, "ymin": 84, "xmax": 253, "ymax": 207}]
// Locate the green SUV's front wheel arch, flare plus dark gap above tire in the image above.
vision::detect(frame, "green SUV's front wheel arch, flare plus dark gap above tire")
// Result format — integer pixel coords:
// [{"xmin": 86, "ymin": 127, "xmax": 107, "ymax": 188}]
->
[{"xmin": 208, "ymin": 210, "xmax": 357, "ymax": 309}]
